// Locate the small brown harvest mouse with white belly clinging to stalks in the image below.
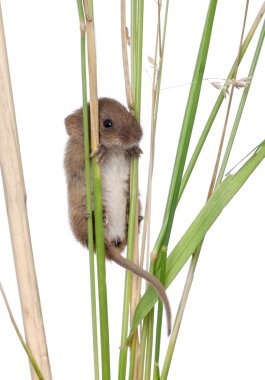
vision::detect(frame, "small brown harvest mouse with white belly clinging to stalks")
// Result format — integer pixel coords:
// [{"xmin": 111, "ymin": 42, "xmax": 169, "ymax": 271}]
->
[{"xmin": 64, "ymin": 98, "xmax": 171, "ymax": 333}]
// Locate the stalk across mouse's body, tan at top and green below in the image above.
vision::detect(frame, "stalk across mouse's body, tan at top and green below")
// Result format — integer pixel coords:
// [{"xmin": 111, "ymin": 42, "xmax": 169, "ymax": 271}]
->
[{"xmin": 83, "ymin": 0, "xmax": 111, "ymax": 380}]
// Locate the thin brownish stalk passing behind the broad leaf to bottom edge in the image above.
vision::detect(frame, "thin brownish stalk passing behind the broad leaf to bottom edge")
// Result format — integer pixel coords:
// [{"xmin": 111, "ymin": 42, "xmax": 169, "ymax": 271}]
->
[{"xmin": 161, "ymin": 4, "xmax": 249, "ymax": 380}]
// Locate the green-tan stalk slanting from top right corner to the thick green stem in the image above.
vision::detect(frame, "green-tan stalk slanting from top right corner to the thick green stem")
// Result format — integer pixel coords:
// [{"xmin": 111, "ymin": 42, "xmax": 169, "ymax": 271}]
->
[{"xmin": 178, "ymin": 2, "xmax": 265, "ymax": 201}]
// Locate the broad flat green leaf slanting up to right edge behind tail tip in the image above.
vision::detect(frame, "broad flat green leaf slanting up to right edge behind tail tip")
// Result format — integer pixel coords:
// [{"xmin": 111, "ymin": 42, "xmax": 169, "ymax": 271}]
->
[{"xmin": 128, "ymin": 141, "xmax": 265, "ymax": 339}]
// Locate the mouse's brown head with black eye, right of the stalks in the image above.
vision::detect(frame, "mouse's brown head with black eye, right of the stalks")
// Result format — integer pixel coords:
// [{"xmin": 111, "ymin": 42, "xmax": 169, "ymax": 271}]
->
[{"xmin": 98, "ymin": 98, "xmax": 142, "ymax": 149}]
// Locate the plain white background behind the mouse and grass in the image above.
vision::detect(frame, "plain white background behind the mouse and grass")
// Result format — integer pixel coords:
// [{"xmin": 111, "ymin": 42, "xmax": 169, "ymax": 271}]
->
[{"xmin": 0, "ymin": 0, "xmax": 265, "ymax": 380}]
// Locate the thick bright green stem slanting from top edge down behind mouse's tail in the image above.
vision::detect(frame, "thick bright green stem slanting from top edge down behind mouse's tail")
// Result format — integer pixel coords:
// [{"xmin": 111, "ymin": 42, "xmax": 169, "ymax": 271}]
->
[{"xmin": 152, "ymin": 0, "xmax": 217, "ymax": 372}]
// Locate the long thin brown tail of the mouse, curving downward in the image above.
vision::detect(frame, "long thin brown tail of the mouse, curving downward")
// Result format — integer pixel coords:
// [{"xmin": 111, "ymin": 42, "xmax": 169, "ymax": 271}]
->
[{"xmin": 111, "ymin": 254, "xmax": 171, "ymax": 335}]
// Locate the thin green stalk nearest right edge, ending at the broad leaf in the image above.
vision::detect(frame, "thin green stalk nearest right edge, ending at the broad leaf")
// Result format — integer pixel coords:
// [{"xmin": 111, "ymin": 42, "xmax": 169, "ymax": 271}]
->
[{"xmin": 216, "ymin": 22, "xmax": 265, "ymax": 186}]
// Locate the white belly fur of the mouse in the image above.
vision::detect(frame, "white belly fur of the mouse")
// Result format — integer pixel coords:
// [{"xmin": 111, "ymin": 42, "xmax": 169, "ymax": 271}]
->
[{"xmin": 101, "ymin": 150, "xmax": 130, "ymax": 242}]
